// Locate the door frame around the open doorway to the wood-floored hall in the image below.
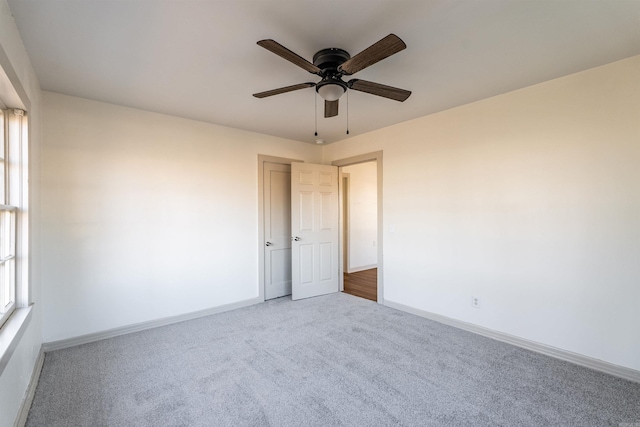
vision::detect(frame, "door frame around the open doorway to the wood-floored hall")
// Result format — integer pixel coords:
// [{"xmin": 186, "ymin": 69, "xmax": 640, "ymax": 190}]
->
[{"xmin": 331, "ymin": 150, "xmax": 384, "ymax": 304}]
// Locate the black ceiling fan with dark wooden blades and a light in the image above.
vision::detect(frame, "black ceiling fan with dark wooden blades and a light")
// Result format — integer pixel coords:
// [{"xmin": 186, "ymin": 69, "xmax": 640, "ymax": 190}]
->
[{"xmin": 253, "ymin": 34, "xmax": 411, "ymax": 117}]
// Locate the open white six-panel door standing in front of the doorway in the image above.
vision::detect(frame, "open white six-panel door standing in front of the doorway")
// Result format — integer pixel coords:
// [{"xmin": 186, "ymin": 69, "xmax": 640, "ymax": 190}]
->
[{"xmin": 291, "ymin": 163, "xmax": 340, "ymax": 300}]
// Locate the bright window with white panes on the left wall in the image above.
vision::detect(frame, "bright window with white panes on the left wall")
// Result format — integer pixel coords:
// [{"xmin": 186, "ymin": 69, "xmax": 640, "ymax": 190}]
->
[{"xmin": 0, "ymin": 109, "xmax": 27, "ymax": 326}]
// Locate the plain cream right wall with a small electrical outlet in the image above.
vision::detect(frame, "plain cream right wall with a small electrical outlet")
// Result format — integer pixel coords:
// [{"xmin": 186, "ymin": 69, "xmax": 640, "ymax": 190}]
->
[{"xmin": 324, "ymin": 56, "xmax": 640, "ymax": 370}]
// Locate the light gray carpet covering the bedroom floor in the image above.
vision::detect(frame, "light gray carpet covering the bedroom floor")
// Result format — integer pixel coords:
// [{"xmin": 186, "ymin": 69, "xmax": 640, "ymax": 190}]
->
[{"xmin": 27, "ymin": 294, "xmax": 640, "ymax": 426}]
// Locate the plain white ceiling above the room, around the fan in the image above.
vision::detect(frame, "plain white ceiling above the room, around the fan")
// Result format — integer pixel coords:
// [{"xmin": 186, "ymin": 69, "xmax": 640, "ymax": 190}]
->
[{"xmin": 8, "ymin": 0, "xmax": 640, "ymax": 143}]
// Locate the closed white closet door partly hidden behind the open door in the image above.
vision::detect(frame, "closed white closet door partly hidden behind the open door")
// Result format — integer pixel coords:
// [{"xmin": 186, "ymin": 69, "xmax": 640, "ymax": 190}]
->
[{"xmin": 263, "ymin": 162, "xmax": 291, "ymax": 299}]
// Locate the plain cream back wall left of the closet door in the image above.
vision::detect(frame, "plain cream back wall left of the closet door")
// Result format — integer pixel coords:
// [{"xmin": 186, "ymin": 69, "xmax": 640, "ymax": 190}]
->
[{"xmin": 42, "ymin": 92, "xmax": 321, "ymax": 342}]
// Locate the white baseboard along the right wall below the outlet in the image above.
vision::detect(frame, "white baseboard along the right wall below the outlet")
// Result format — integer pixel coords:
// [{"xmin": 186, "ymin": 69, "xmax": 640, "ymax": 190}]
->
[{"xmin": 384, "ymin": 300, "xmax": 640, "ymax": 383}]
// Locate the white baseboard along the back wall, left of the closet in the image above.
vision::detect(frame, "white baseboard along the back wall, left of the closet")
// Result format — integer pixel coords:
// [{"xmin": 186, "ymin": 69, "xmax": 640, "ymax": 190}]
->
[{"xmin": 43, "ymin": 297, "xmax": 263, "ymax": 352}]
